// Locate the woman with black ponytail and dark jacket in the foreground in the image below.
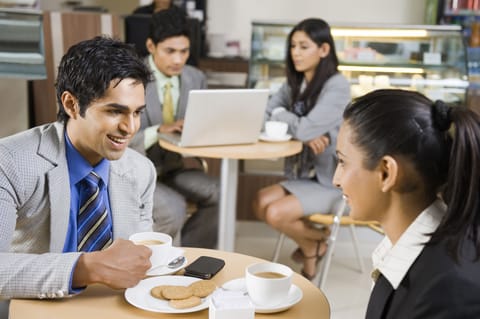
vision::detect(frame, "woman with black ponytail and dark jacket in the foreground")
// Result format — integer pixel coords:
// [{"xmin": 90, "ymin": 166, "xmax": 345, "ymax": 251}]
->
[{"xmin": 334, "ymin": 90, "xmax": 480, "ymax": 319}]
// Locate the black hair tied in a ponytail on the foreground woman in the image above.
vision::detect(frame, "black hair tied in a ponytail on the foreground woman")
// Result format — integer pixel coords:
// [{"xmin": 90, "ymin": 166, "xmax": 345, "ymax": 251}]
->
[{"xmin": 343, "ymin": 90, "xmax": 480, "ymax": 258}]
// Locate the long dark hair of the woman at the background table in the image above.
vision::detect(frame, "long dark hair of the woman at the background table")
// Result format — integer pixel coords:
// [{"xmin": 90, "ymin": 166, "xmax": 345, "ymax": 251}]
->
[{"xmin": 286, "ymin": 18, "xmax": 338, "ymax": 113}]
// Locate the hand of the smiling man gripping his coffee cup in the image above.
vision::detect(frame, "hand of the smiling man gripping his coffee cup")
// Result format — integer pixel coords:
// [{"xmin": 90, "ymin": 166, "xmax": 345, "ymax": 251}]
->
[{"xmin": 72, "ymin": 239, "xmax": 152, "ymax": 289}]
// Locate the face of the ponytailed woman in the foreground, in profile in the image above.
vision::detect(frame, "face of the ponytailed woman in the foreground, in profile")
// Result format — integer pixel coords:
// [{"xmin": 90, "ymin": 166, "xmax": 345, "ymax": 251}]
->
[{"xmin": 333, "ymin": 122, "xmax": 385, "ymax": 220}]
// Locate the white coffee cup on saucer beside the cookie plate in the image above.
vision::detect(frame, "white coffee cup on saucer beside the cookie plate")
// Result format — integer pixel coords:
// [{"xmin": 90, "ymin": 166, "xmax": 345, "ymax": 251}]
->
[{"xmin": 245, "ymin": 262, "xmax": 293, "ymax": 306}]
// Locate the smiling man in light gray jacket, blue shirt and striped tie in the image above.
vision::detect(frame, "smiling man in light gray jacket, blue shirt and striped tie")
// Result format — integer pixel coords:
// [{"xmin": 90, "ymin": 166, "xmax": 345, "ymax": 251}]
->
[{"xmin": 0, "ymin": 37, "xmax": 156, "ymax": 299}]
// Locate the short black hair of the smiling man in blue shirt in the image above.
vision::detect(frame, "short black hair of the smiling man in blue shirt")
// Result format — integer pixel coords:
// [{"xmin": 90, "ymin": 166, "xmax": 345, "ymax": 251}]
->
[{"xmin": 55, "ymin": 36, "xmax": 150, "ymax": 123}]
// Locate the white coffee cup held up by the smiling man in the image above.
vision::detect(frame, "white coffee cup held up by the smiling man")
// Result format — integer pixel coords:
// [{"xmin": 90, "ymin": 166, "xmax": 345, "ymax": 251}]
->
[{"xmin": 128, "ymin": 232, "xmax": 172, "ymax": 268}]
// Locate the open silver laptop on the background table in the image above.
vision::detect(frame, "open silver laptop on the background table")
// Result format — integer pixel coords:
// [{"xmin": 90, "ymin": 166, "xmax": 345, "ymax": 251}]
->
[{"xmin": 159, "ymin": 89, "xmax": 269, "ymax": 147}]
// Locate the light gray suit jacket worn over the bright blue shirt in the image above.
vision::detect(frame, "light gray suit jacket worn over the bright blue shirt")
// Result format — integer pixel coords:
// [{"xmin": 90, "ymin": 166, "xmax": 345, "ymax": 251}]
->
[{"xmin": 0, "ymin": 122, "xmax": 156, "ymax": 299}]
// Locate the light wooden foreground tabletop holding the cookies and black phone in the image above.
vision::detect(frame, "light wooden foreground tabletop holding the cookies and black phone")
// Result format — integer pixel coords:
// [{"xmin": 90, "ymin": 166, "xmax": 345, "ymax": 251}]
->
[{"xmin": 9, "ymin": 248, "xmax": 330, "ymax": 319}]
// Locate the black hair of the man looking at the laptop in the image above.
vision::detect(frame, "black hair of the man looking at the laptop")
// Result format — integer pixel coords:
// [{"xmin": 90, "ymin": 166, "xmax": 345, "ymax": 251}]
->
[{"xmin": 148, "ymin": 6, "xmax": 190, "ymax": 45}]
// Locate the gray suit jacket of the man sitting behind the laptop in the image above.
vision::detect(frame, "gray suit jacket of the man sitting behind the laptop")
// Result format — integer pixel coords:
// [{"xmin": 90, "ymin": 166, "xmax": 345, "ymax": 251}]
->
[{"xmin": 130, "ymin": 60, "xmax": 207, "ymax": 154}]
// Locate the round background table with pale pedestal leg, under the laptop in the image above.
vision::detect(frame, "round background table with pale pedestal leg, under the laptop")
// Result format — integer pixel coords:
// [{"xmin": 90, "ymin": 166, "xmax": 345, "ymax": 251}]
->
[{"xmin": 160, "ymin": 140, "xmax": 302, "ymax": 251}]
